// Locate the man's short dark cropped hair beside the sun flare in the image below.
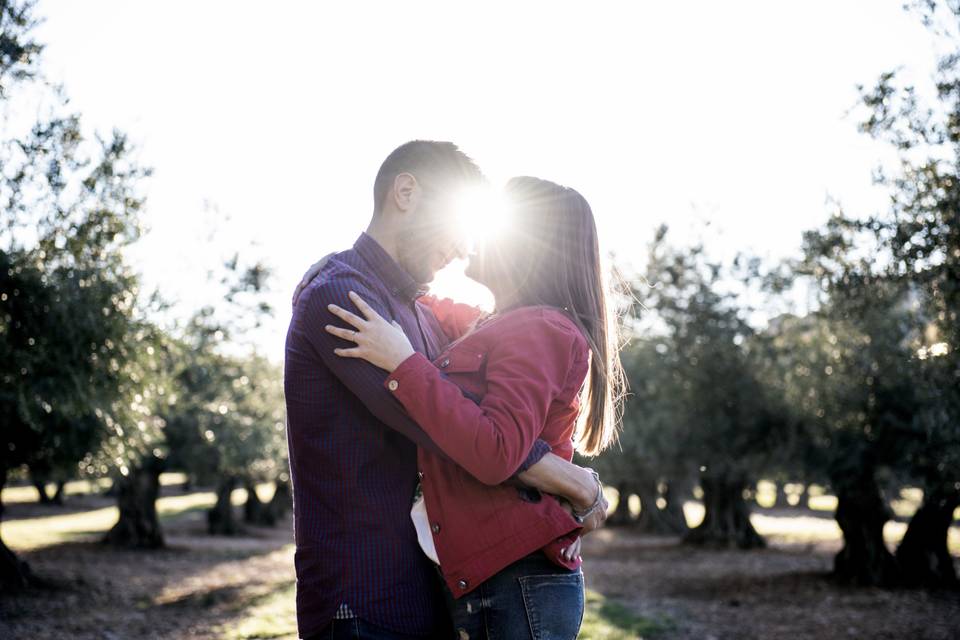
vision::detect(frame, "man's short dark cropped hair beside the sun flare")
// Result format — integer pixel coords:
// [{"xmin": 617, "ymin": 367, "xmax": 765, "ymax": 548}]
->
[{"xmin": 373, "ymin": 140, "xmax": 484, "ymax": 215}]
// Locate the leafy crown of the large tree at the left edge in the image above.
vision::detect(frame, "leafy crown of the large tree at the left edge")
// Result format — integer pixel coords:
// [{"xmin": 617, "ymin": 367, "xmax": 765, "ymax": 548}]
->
[{"xmin": 0, "ymin": 2, "xmax": 162, "ymax": 560}]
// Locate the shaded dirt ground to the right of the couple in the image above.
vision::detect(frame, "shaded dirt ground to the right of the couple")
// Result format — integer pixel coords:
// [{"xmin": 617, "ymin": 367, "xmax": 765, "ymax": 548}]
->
[{"xmin": 584, "ymin": 529, "xmax": 960, "ymax": 640}]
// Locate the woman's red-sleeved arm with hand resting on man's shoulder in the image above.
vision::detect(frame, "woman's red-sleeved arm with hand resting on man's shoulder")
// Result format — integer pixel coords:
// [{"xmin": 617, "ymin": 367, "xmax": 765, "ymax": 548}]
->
[{"xmin": 327, "ymin": 295, "xmax": 587, "ymax": 485}]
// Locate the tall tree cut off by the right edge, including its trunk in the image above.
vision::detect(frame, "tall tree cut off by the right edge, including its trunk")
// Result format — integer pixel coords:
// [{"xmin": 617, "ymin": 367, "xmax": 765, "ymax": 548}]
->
[{"xmin": 848, "ymin": 0, "xmax": 960, "ymax": 586}]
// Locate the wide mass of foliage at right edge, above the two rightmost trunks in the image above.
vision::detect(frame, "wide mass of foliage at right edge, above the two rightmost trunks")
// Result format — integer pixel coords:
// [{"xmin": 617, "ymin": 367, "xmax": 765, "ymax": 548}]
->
[{"xmin": 777, "ymin": 0, "xmax": 960, "ymax": 498}]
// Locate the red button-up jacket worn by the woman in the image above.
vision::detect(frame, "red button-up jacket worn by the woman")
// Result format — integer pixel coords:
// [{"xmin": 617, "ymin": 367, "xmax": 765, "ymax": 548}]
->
[{"xmin": 384, "ymin": 297, "xmax": 589, "ymax": 597}]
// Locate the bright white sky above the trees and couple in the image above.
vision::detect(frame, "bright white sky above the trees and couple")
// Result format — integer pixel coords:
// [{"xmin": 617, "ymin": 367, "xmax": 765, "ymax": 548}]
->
[{"xmin": 31, "ymin": 0, "xmax": 935, "ymax": 360}]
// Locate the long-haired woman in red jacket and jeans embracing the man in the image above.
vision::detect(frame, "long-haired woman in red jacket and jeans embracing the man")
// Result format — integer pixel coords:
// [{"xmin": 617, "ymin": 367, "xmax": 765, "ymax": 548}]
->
[{"xmin": 327, "ymin": 178, "xmax": 622, "ymax": 638}]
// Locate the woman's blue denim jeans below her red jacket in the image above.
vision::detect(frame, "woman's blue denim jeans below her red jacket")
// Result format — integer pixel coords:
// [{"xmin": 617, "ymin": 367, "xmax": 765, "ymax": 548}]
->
[{"xmin": 445, "ymin": 551, "xmax": 583, "ymax": 640}]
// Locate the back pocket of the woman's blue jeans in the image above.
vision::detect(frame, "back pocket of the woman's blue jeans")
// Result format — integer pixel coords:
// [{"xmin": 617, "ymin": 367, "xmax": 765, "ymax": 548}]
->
[{"xmin": 519, "ymin": 571, "xmax": 583, "ymax": 640}]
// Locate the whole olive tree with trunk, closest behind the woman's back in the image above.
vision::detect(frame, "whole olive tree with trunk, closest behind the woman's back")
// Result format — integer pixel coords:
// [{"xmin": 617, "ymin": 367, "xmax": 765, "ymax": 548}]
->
[{"xmin": 629, "ymin": 227, "xmax": 781, "ymax": 549}]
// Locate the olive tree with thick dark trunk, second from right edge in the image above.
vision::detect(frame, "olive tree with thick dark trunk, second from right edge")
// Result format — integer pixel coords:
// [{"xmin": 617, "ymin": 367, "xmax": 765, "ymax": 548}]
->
[{"xmin": 767, "ymin": 268, "xmax": 914, "ymax": 585}]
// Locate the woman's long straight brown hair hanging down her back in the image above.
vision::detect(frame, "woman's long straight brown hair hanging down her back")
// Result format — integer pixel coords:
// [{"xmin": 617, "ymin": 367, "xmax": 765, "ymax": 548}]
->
[{"xmin": 484, "ymin": 177, "xmax": 624, "ymax": 455}]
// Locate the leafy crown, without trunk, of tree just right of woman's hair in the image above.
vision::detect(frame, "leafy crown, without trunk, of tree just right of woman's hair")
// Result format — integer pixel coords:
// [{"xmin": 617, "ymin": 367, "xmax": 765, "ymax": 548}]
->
[{"xmin": 608, "ymin": 227, "xmax": 781, "ymax": 490}]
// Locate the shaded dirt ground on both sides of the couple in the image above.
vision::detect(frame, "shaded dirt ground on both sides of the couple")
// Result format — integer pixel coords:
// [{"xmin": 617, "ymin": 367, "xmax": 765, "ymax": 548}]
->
[{"xmin": 0, "ymin": 488, "xmax": 960, "ymax": 640}]
